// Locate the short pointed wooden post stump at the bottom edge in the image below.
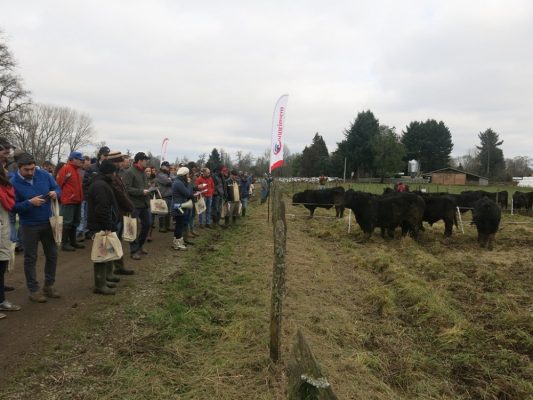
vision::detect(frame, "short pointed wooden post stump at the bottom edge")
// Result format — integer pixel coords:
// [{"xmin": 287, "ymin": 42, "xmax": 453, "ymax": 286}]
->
[{"xmin": 288, "ymin": 329, "xmax": 338, "ymax": 400}]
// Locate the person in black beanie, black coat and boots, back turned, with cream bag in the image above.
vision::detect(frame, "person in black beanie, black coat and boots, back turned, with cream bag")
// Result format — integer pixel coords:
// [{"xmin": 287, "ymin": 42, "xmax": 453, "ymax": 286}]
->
[{"xmin": 87, "ymin": 160, "xmax": 120, "ymax": 295}]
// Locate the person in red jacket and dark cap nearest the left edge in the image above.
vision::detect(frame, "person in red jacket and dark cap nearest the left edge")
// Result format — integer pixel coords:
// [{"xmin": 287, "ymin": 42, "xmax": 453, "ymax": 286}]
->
[{"xmin": 56, "ymin": 151, "xmax": 85, "ymax": 251}]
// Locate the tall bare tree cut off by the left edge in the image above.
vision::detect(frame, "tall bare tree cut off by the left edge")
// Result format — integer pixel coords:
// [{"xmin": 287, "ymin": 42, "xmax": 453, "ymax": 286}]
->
[{"xmin": 0, "ymin": 31, "xmax": 30, "ymax": 137}]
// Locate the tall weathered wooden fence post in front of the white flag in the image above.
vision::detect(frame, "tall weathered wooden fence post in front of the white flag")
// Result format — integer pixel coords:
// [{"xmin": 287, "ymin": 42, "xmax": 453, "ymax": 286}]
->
[{"xmin": 270, "ymin": 184, "xmax": 287, "ymax": 363}]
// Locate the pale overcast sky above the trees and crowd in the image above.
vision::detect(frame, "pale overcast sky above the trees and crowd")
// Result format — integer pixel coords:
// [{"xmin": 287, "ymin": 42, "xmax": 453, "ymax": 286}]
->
[{"xmin": 0, "ymin": 0, "xmax": 533, "ymax": 160}]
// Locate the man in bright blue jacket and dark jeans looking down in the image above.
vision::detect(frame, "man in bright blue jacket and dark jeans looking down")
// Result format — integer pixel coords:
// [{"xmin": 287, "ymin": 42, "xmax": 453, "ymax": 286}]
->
[{"xmin": 11, "ymin": 153, "xmax": 61, "ymax": 303}]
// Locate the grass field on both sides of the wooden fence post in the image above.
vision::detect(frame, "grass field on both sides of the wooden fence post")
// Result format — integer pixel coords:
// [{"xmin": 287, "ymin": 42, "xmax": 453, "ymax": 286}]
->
[{"xmin": 2, "ymin": 185, "xmax": 533, "ymax": 400}]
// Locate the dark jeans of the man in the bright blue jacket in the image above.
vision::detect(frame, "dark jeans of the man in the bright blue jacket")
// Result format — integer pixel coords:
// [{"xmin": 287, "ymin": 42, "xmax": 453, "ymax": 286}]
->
[{"xmin": 22, "ymin": 222, "xmax": 57, "ymax": 293}]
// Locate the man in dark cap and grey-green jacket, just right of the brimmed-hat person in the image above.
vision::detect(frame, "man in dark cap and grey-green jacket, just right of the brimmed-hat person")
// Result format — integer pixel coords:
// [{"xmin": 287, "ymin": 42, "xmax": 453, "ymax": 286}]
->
[{"xmin": 122, "ymin": 152, "xmax": 152, "ymax": 260}]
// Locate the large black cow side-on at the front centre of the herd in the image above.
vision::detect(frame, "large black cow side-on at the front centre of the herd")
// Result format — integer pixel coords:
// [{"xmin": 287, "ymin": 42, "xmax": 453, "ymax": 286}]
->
[{"xmin": 344, "ymin": 190, "xmax": 425, "ymax": 239}]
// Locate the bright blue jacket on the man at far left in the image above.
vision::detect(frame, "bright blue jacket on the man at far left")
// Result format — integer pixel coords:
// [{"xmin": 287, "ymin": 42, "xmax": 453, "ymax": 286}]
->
[{"xmin": 11, "ymin": 169, "xmax": 61, "ymax": 225}]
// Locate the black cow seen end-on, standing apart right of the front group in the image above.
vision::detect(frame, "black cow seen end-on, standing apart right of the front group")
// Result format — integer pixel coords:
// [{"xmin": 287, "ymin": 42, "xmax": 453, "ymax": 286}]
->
[{"xmin": 472, "ymin": 197, "xmax": 502, "ymax": 250}]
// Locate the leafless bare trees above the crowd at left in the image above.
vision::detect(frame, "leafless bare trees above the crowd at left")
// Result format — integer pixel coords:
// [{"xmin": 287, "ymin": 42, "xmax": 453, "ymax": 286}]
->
[{"xmin": 0, "ymin": 31, "xmax": 95, "ymax": 163}]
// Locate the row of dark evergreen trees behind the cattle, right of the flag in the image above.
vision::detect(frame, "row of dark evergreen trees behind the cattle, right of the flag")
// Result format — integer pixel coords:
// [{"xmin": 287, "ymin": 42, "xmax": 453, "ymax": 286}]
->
[{"xmin": 291, "ymin": 110, "xmax": 533, "ymax": 181}]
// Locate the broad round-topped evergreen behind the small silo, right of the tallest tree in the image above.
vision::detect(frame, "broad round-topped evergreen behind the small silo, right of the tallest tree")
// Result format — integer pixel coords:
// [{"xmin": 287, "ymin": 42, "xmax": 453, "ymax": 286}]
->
[{"xmin": 401, "ymin": 119, "xmax": 453, "ymax": 171}]
